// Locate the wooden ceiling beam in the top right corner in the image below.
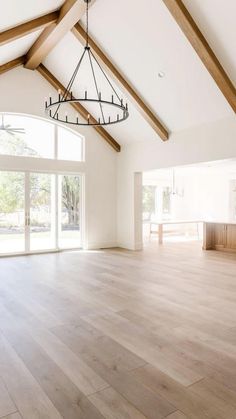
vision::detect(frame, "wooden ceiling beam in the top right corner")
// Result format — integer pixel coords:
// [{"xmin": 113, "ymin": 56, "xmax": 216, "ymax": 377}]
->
[{"xmin": 163, "ymin": 0, "xmax": 236, "ymax": 112}]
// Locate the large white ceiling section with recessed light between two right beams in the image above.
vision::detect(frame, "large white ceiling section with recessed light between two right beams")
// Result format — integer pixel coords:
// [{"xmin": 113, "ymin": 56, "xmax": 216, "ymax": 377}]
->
[{"xmin": 79, "ymin": 0, "xmax": 234, "ymax": 131}]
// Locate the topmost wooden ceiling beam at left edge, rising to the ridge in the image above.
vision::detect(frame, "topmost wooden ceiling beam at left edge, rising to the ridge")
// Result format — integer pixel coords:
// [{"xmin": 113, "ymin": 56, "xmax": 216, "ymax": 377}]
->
[{"xmin": 0, "ymin": 11, "xmax": 59, "ymax": 45}]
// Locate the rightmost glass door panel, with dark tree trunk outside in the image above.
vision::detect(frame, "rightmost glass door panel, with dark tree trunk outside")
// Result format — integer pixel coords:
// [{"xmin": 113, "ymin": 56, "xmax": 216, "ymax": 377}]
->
[{"xmin": 58, "ymin": 175, "xmax": 81, "ymax": 249}]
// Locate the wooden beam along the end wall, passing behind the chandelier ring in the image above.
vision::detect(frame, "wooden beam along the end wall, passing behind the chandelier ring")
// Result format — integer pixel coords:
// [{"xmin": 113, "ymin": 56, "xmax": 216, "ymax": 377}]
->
[{"xmin": 37, "ymin": 64, "xmax": 120, "ymax": 151}]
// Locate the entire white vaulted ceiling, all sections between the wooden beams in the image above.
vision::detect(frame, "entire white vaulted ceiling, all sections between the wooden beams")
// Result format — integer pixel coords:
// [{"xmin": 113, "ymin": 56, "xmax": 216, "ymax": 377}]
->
[{"xmin": 0, "ymin": 0, "xmax": 236, "ymax": 144}]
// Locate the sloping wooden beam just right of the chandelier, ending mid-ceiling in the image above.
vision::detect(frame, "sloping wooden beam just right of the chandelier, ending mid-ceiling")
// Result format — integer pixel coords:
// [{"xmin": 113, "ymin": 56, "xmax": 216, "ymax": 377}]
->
[{"xmin": 71, "ymin": 23, "xmax": 169, "ymax": 141}]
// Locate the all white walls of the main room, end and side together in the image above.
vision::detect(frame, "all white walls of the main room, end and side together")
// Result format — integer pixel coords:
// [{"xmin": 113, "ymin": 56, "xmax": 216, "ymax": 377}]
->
[{"xmin": 0, "ymin": 68, "xmax": 236, "ymax": 249}]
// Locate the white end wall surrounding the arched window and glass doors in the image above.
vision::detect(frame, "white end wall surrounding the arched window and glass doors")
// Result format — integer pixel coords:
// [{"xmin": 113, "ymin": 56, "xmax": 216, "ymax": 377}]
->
[{"xmin": 0, "ymin": 68, "xmax": 117, "ymax": 248}]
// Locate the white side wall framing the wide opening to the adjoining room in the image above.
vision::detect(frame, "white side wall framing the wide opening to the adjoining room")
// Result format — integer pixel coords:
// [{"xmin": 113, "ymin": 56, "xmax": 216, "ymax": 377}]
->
[{"xmin": 117, "ymin": 117, "xmax": 236, "ymax": 249}]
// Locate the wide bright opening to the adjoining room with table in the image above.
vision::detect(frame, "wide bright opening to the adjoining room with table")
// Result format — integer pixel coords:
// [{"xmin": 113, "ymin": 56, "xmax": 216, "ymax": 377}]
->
[{"xmin": 142, "ymin": 160, "xmax": 236, "ymax": 245}]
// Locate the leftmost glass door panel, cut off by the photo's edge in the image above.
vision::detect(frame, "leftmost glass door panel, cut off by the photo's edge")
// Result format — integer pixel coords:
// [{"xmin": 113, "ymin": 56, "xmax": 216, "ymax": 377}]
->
[{"xmin": 0, "ymin": 171, "xmax": 25, "ymax": 254}]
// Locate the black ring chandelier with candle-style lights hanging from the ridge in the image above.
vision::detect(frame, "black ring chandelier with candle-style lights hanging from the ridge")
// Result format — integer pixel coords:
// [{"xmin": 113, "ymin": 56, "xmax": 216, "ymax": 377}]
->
[{"xmin": 45, "ymin": 0, "xmax": 129, "ymax": 126}]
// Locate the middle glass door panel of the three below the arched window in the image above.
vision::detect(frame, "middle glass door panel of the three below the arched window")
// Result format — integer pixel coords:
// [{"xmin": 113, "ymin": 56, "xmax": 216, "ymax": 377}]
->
[{"xmin": 30, "ymin": 173, "xmax": 56, "ymax": 251}]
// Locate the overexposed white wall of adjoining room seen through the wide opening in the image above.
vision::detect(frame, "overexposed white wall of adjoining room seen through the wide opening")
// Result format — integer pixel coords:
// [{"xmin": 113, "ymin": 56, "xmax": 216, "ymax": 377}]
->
[{"xmin": 143, "ymin": 170, "xmax": 231, "ymax": 220}]
